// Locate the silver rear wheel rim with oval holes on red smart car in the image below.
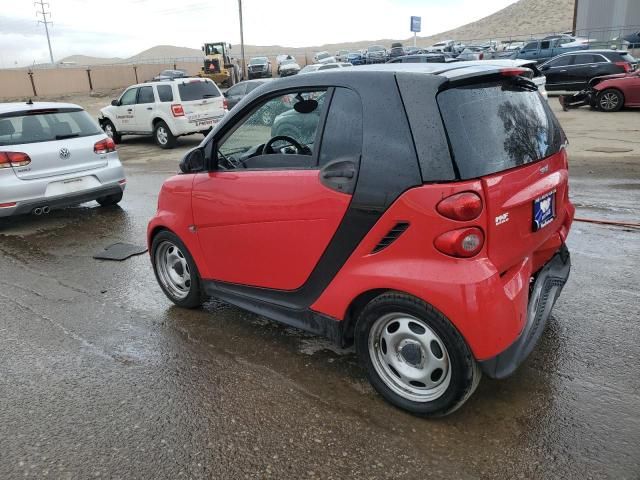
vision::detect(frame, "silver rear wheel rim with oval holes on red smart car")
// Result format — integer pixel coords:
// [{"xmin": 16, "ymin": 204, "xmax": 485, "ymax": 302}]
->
[{"xmin": 369, "ymin": 312, "xmax": 451, "ymax": 403}]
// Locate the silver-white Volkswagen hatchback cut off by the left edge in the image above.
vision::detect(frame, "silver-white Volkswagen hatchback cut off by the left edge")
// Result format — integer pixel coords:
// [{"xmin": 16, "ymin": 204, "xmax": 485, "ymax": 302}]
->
[{"xmin": 0, "ymin": 101, "xmax": 126, "ymax": 217}]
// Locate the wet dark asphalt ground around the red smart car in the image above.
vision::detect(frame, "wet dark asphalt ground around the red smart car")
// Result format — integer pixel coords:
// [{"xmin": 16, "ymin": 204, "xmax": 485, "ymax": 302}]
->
[{"xmin": 0, "ymin": 132, "xmax": 640, "ymax": 479}]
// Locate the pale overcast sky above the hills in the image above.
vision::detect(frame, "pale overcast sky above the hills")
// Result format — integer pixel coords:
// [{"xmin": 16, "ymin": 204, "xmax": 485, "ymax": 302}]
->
[{"xmin": 0, "ymin": 0, "xmax": 516, "ymax": 68}]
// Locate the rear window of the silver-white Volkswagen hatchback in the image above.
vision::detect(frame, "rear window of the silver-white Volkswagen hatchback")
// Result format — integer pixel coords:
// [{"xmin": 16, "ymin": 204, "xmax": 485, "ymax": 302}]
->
[{"xmin": 0, "ymin": 109, "xmax": 102, "ymax": 147}]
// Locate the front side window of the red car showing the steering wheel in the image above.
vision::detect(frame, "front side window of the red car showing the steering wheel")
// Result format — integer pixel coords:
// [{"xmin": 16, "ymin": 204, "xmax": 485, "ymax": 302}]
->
[{"xmin": 217, "ymin": 89, "xmax": 327, "ymax": 170}]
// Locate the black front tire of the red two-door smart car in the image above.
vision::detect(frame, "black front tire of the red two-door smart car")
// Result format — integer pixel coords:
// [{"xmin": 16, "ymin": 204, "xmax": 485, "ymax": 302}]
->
[{"xmin": 151, "ymin": 230, "xmax": 206, "ymax": 308}]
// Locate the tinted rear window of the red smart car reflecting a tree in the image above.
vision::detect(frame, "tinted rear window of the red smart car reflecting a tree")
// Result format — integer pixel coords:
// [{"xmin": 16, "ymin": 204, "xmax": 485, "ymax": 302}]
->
[{"xmin": 438, "ymin": 82, "xmax": 565, "ymax": 179}]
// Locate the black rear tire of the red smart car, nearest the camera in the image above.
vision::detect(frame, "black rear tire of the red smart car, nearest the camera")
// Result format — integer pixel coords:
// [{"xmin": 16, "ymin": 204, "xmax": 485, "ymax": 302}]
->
[{"xmin": 355, "ymin": 292, "xmax": 482, "ymax": 417}]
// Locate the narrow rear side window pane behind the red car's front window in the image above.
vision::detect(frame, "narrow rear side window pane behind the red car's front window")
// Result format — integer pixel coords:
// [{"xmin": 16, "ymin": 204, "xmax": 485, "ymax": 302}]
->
[{"xmin": 319, "ymin": 88, "xmax": 362, "ymax": 168}]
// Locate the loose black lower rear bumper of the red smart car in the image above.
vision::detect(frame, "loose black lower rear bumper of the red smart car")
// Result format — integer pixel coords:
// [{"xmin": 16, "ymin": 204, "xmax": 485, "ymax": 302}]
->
[{"xmin": 479, "ymin": 244, "xmax": 571, "ymax": 378}]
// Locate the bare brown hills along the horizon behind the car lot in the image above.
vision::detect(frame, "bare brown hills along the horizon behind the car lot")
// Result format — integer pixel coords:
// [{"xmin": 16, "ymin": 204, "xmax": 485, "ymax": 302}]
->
[{"xmin": 57, "ymin": 0, "xmax": 574, "ymax": 65}]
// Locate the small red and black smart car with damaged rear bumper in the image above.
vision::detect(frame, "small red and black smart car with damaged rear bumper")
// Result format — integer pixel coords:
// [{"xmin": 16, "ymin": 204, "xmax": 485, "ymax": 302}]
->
[{"xmin": 148, "ymin": 63, "xmax": 574, "ymax": 416}]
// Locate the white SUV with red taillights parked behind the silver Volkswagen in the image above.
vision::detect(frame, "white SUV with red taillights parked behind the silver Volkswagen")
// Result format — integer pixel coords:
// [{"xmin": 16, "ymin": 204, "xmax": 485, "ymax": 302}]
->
[{"xmin": 98, "ymin": 78, "xmax": 227, "ymax": 148}]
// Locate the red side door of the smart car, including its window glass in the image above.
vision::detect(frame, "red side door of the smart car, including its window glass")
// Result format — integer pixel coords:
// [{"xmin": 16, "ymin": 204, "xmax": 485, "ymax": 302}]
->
[{"xmin": 192, "ymin": 88, "xmax": 362, "ymax": 291}]
